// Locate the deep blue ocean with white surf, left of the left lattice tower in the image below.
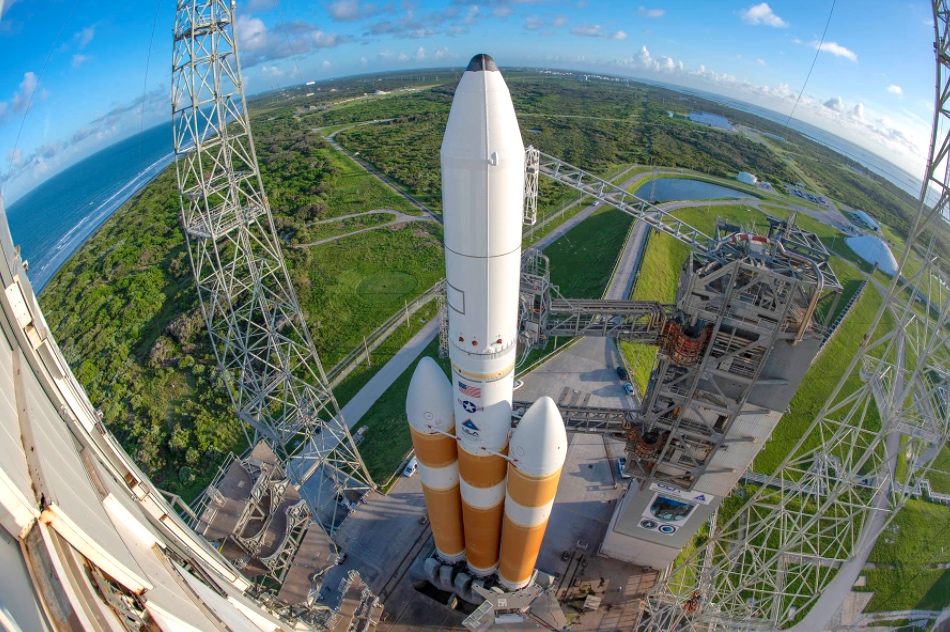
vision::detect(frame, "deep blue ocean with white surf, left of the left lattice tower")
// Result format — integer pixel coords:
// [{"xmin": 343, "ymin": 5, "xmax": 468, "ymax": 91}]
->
[{"xmin": 6, "ymin": 122, "xmax": 175, "ymax": 293}]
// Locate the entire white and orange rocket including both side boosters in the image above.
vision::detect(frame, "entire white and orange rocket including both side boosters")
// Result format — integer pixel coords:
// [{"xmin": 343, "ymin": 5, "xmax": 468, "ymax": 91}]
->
[{"xmin": 406, "ymin": 55, "xmax": 567, "ymax": 590}]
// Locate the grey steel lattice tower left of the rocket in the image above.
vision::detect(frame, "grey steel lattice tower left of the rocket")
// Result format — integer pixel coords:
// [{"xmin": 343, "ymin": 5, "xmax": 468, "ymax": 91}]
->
[{"xmin": 171, "ymin": 0, "xmax": 373, "ymax": 528}]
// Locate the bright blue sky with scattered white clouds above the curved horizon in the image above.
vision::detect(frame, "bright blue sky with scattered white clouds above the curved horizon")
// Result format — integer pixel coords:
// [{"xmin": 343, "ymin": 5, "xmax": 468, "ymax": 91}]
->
[{"xmin": 0, "ymin": 0, "xmax": 934, "ymax": 203}]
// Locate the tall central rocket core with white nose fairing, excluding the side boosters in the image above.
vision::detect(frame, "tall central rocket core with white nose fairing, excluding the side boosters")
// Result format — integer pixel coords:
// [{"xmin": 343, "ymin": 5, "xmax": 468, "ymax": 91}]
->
[{"xmin": 441, "ymin": 55, "xmax": 524, "ymax": 575}]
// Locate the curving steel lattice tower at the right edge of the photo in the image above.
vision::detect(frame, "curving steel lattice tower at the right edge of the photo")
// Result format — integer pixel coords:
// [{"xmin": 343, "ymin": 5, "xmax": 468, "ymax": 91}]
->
[{"xmin": 638, "ymin": 0, "xmax": 950, "ymax": 632}]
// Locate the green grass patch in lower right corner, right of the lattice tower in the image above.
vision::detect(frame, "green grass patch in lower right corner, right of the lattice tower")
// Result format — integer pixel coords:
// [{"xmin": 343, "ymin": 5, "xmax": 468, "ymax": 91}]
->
[{"xmin": 864, "ymin": 500, "xmax": 950, "ymax": 612}]
